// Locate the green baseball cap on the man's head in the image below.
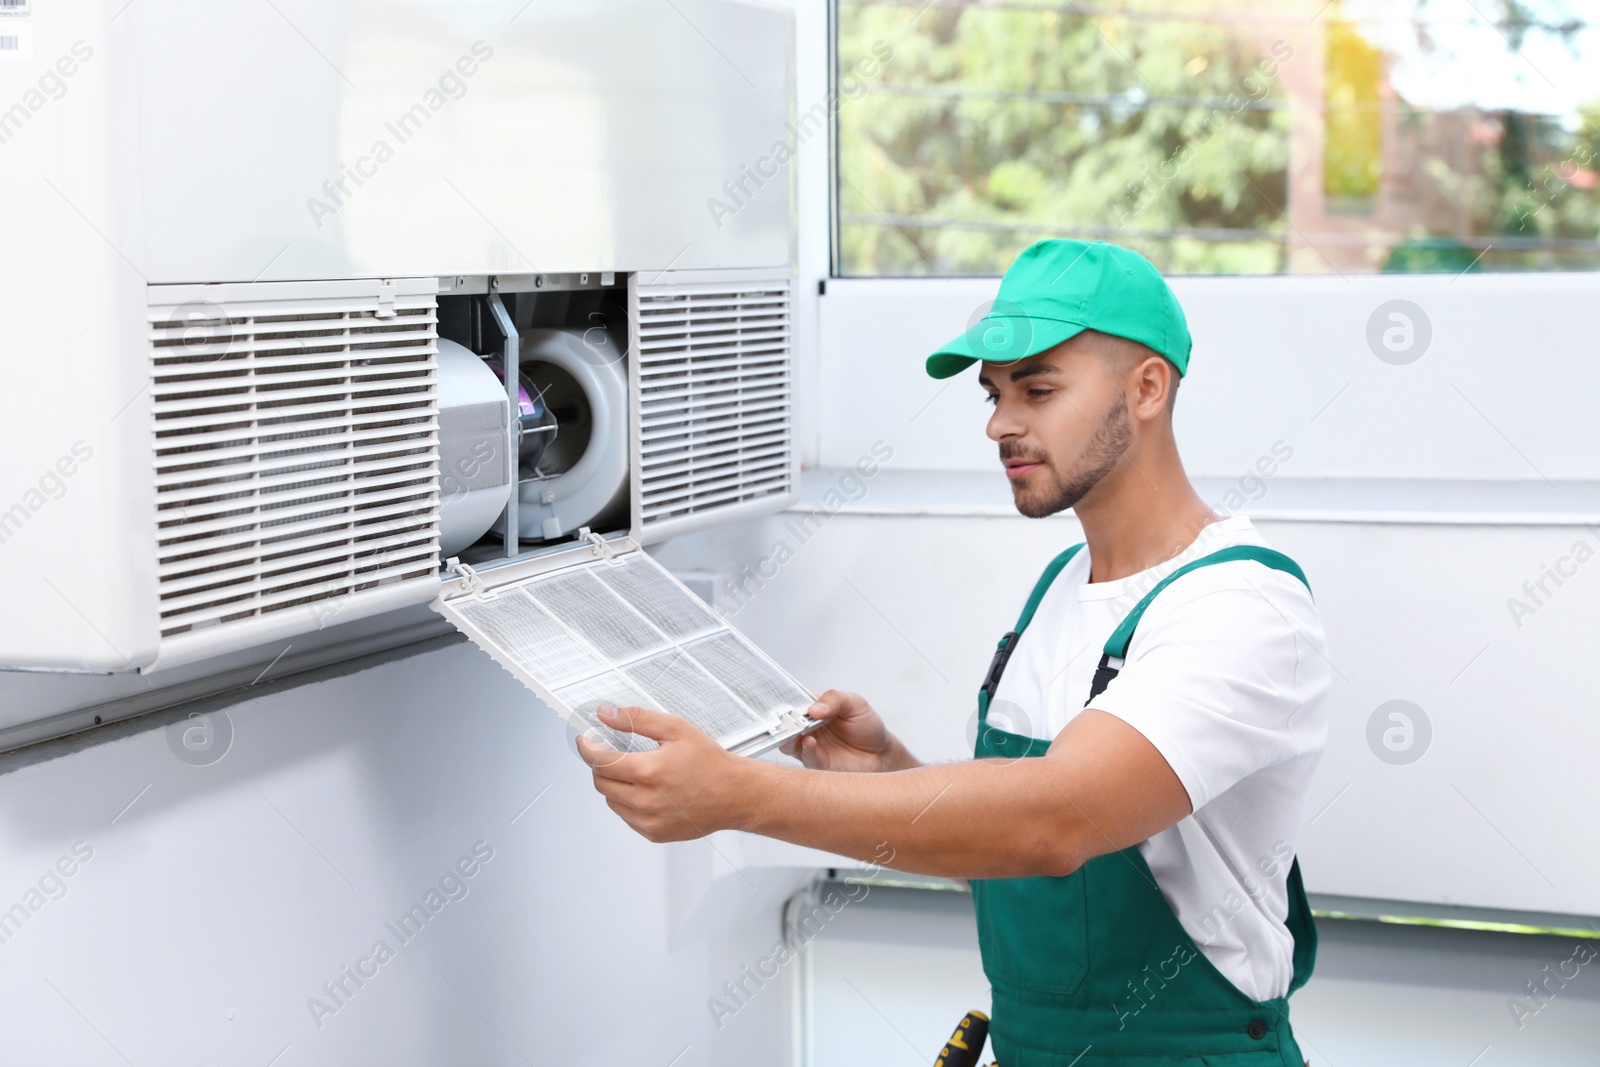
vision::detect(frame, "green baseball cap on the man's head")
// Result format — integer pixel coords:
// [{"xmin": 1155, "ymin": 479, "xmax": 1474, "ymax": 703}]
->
[{"xmin": 928, "ymin": 240, "xmax": 1189, "ymax": 378}]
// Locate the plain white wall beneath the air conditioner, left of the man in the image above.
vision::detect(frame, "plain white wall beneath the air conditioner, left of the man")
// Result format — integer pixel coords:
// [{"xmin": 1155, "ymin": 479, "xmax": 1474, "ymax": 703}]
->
[{"xmin": 0, "ymin": 641, "xmax": 803, "ymax": 1067}]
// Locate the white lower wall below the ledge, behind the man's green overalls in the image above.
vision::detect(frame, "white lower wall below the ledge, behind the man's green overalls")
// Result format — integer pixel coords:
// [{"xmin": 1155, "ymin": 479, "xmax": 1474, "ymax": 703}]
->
[{"xmin": 813, "ymin": 888, "xmax": 1600, "ymax": 1067}]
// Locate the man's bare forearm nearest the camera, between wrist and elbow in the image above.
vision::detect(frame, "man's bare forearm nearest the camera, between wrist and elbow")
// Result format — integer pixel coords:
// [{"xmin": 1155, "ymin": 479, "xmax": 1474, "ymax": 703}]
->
[{"xmin": 733, "ymin": 745, "xmax": 1085, "ymax": 878}]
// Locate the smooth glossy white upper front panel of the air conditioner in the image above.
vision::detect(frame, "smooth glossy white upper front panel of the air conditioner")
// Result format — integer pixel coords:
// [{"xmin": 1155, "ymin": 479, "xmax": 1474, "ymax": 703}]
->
[{"xmin": 116, "ymin": 0, "xmax": 790, "ymax": 283}]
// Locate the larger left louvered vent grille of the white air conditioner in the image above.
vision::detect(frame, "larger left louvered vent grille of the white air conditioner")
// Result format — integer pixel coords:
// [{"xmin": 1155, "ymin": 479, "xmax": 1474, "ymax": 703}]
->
[{"xmin": 149, "ymin": 283, "xmax": 438, "ymax": 638}]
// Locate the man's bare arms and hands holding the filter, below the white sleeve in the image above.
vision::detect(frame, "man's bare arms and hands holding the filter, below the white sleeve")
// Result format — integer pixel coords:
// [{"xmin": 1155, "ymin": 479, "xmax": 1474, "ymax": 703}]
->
[{"xmin": 578, "ymin": 693, "xmax": 1190, "ymax": 878}]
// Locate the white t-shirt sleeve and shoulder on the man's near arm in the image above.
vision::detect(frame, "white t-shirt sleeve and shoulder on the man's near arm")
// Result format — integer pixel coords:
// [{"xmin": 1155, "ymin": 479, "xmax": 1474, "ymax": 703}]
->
[{"xmin": 1088, "ymin": 560, "xmax": 1333, "ymax": 809}]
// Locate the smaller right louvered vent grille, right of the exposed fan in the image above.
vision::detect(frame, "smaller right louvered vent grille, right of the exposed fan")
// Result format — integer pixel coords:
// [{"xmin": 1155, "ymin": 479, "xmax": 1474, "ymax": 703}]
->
[{"xmin": 632, "ymin": 272, "xmax": 794, "ymax": 539}]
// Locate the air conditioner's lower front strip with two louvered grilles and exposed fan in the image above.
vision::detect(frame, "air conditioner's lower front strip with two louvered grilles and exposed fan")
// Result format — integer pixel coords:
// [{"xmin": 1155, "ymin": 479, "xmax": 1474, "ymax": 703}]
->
[{"xmin": 131, "ymin": 270, "xmax": 794, "ymax": 659}]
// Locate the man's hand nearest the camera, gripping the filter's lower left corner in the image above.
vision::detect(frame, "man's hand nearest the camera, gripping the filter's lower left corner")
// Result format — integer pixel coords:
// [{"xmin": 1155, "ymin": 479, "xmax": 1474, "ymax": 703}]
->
[{"xmin": 578, "ymin": 707, "xmax": 750, "ymax": 841}]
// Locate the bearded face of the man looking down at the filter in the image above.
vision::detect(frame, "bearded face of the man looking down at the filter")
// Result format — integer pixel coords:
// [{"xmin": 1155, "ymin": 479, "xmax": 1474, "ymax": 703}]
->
[{"xmin": 978, "ymin": 334, "xmax": 1133, "ymax": 518}]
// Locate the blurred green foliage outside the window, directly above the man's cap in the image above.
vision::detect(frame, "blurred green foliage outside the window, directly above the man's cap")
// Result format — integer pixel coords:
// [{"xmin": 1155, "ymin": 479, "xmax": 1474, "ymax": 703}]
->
[{"xmin": 838, "ymin": 2, "xmax": 1288, "ymax": 274}]
